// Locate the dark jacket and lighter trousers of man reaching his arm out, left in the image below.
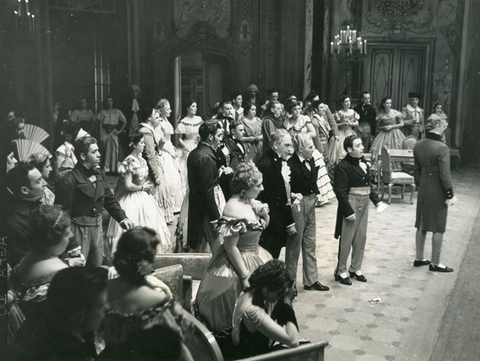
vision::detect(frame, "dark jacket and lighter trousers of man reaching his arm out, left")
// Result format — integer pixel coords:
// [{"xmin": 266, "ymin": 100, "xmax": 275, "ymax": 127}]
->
[{"xmin": 55, "ymin": 162, "xmax": 127, "ymax": 267}]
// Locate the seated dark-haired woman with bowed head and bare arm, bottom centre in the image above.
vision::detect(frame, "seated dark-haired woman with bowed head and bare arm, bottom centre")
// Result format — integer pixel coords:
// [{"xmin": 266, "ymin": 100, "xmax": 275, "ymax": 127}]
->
[{"xmin": 225, "ymin": 260, "xmax": 299, "ymax": 359}]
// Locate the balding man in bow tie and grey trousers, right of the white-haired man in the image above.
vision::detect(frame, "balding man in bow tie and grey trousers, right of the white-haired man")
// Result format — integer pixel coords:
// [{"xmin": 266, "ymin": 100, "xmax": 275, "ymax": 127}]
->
[{"xmin": 285, "ymin": 133, "xmax": 329, "ymax": 291}]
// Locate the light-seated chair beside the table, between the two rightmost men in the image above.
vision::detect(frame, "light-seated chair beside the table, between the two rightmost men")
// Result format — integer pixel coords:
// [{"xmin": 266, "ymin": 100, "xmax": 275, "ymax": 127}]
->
[{"xmin": 378, "ymin": 147, "xmax": 415, "ymax": 204}]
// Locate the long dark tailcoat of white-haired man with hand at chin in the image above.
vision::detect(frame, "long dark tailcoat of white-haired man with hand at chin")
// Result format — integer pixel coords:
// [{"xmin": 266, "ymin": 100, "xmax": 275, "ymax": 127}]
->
[{"xmin": 257, "ymin": 149, "xmax": 294, "ymax": 258}]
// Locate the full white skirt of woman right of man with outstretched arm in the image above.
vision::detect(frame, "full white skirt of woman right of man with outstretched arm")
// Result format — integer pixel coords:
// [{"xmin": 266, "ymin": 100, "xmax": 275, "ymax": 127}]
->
[{"xmin": 106, "ymin": 191, "xmax": 173, "ymax": 258}]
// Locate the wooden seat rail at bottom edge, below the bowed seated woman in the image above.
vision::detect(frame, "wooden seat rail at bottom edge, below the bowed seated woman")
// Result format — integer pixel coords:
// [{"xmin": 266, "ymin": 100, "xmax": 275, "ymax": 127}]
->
[{"xmin": 237, "ymin": 341, "xmax": 328, "ymax": 361}]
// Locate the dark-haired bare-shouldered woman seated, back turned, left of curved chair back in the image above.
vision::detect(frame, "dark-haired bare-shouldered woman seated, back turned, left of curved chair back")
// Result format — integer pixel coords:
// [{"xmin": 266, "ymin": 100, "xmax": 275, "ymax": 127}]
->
[{"xmin": 102, "ymin": 227, "xmax": 192, "ymax": 360}]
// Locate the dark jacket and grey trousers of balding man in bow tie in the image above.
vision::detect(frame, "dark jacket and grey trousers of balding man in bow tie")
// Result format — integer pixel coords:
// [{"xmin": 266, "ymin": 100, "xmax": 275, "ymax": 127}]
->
[{"xmin": 285, "ymin": 153, "xmax": 320, "ymax": 286}]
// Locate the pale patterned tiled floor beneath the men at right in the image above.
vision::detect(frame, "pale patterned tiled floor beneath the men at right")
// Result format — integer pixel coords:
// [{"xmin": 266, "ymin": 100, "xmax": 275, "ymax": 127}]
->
[{"xmin": 284, "ymin": 169, "xmax": 480, "ymax": 361}]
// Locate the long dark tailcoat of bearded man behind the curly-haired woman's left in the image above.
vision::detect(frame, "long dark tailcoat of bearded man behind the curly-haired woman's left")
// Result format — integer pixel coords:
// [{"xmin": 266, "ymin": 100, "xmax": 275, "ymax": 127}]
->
[{"xmin": 187, "ymin": 143, "xmax": 220, "ymax": 250}]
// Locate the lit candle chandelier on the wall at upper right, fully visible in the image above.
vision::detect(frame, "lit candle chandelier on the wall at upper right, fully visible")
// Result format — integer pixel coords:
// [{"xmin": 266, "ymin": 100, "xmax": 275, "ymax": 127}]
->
[{"xmin": 330, "ymin": 26, "xmax": 367, "ymax": 63}]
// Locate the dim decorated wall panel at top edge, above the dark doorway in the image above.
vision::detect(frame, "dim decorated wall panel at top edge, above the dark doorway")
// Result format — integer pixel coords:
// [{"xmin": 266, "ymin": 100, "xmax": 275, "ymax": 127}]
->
[{"xmin": 173, "ymin": 0, "xmax": 232, "ymax": 39}]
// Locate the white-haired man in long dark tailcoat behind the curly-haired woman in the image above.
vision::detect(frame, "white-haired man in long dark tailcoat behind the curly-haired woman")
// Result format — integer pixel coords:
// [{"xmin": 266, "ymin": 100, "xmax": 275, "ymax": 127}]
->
[{"xmin": 257, "ymin": 128, "xmax": 296, "ymax": 258}]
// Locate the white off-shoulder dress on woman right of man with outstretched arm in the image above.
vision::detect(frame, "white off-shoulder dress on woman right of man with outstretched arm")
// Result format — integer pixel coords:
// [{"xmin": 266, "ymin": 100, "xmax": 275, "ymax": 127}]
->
[{"xmin": 107, "ymin": 154, "xmax": 172, "ymax": 256}]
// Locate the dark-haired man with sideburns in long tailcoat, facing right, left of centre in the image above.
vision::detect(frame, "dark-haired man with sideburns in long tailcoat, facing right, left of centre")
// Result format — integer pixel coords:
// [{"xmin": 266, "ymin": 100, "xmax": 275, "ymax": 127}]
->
[{"xmin": 187, "ymin": 119, "xmax": 226, "ymax": 253}]
